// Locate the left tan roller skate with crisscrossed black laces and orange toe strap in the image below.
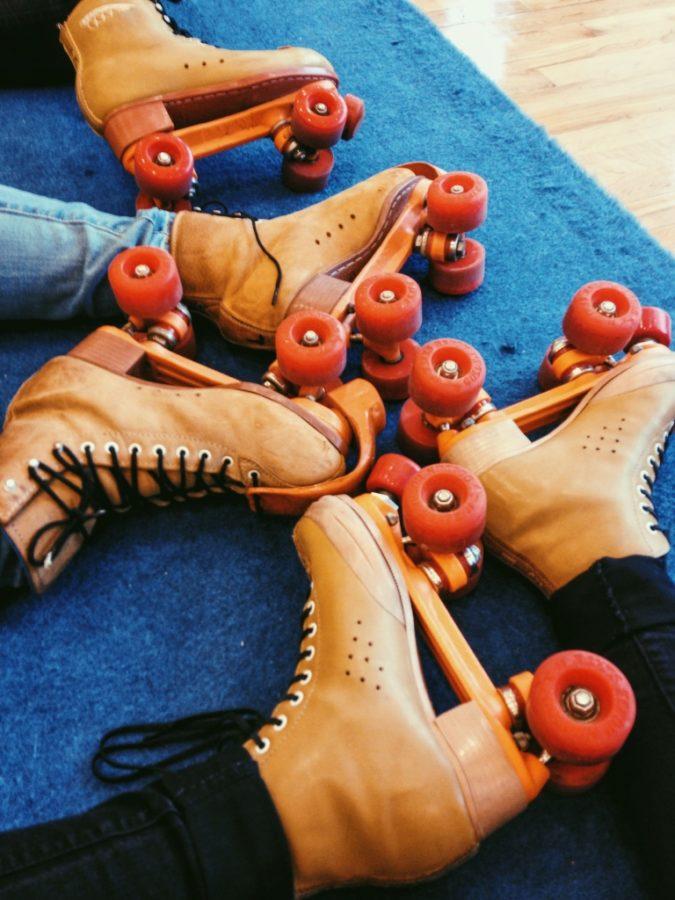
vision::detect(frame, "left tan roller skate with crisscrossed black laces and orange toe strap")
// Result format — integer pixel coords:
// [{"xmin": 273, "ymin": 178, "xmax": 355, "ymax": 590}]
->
[{"xmin": 0, "ymin": 247, "xmax": 385, "ymax": 591}]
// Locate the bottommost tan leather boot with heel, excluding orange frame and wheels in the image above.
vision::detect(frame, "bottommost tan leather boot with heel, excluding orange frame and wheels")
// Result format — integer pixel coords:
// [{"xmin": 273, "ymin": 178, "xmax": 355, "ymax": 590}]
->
[{"xmin": 246, "ymin": 496, "xmax": 526, "ymax": 895}]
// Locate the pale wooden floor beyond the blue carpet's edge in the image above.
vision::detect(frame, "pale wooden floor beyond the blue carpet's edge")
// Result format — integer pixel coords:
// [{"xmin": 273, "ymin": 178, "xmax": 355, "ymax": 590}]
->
[{"xmin": 415, "ymin": 0, "xmax": 675, "ymax": 251}]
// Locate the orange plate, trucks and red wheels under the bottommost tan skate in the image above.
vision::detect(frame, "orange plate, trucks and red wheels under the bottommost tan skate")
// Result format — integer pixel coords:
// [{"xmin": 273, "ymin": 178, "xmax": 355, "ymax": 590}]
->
[{"xmin": 356, "ymin": 454, "xmax": 635, "ymax": 801}]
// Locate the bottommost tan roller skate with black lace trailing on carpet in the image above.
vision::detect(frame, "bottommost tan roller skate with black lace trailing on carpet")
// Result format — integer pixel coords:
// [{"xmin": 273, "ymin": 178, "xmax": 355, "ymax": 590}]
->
[{"xmin": 95, "ymin": 496, "xmax": 635, "ymax": 896}]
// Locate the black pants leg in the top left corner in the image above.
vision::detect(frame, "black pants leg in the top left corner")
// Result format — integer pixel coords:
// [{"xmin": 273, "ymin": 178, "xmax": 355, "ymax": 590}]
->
[{"xmin": 0, "ymin": 0, "xmax": 75, "ymax": 88}]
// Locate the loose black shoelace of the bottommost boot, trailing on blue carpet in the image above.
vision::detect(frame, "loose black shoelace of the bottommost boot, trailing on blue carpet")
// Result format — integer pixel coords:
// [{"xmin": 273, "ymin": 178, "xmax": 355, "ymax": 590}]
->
[{"xmin": 92, "ymin": 606, "xmax": 313, "ymax": 784}]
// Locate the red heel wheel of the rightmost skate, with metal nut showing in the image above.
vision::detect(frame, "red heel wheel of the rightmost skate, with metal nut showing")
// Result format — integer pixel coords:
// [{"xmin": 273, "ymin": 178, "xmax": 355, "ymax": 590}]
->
[{"xmin": 410, "ymin": 338, "xmax": 485, "ymax": 418}]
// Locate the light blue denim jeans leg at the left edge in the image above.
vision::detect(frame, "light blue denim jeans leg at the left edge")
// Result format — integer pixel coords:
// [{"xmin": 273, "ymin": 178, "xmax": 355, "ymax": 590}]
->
[{"xmin": 0, "ymin": 185, "xmax": 174, "ymax": 319}]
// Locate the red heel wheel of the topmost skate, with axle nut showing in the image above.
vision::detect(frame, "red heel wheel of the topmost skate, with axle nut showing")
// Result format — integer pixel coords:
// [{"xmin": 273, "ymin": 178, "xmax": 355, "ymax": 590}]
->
[{"xmin": 134, "ymin": 133, "xmax": 195, "ymax": 203}]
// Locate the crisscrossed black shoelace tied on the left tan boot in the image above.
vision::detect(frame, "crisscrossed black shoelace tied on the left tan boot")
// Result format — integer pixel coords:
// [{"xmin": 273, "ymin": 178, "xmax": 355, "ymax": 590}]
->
[{"xmin": 27, "ymin": 443, "xmax": 233, "ymax": 567}]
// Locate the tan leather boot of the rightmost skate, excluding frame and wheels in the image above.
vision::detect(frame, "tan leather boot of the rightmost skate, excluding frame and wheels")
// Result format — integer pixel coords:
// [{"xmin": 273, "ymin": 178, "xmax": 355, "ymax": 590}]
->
[{"xmin": 444, "ymin": 344, "xmax": 675, "ymax": 595}]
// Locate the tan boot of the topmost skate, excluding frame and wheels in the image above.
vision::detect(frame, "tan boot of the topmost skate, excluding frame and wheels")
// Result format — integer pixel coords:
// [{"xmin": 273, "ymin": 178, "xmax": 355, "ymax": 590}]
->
[{"xmin": 61, "ymin": 0, "xmax": 337, "ymax": 140}]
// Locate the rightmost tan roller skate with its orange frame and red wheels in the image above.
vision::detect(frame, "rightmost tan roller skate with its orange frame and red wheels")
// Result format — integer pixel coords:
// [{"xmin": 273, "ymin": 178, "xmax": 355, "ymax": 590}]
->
[{"xmin": 399, "ymin": 282, "xmax": 675, "ymax": 596}]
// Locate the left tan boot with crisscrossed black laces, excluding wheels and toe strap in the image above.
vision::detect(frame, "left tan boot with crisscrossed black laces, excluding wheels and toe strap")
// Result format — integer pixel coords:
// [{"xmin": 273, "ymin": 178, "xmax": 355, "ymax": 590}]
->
[{"xmin": 0, "ymin": 329, "xmax": 347, "ymax": 591}]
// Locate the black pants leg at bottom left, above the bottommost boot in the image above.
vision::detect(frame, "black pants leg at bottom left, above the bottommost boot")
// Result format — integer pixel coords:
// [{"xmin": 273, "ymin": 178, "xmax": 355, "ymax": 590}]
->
[{"xmin": 0, "ymin": 746, "xmax": 293, "ymax": 900}]
